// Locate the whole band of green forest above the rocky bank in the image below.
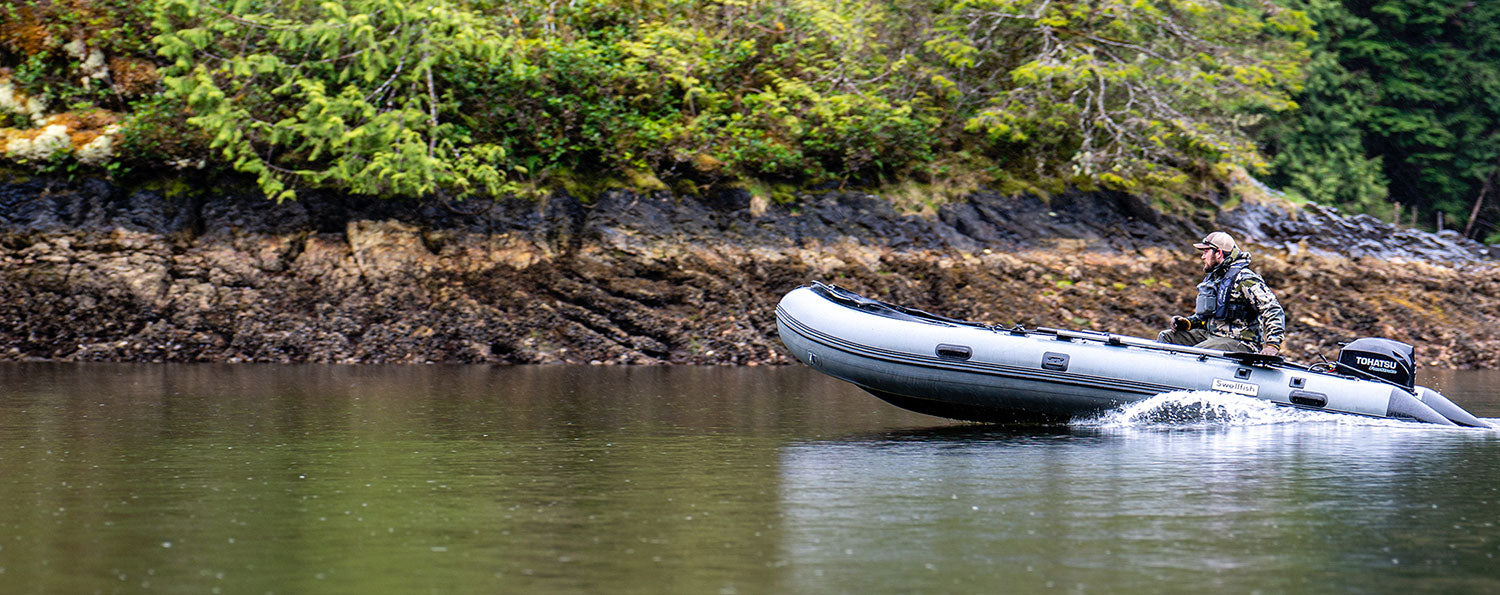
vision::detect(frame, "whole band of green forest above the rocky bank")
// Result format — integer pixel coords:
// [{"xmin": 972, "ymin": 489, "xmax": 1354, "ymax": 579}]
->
[{"xmin": 0, "ymin": 0, "xmax": 1500, "ymax": 243}]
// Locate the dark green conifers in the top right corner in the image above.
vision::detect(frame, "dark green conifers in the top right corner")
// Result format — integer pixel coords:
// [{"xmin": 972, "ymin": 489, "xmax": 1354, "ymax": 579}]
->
[{"xmin": 1263, "ymin": 0, "xmax": 1500, "ymax": 234}]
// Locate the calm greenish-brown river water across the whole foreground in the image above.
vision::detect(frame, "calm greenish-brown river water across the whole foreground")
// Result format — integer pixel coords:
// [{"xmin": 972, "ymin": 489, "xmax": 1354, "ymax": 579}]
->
[{"xmin": 0, "ymin": 364, "xmax": 1500, "ymax": 594}]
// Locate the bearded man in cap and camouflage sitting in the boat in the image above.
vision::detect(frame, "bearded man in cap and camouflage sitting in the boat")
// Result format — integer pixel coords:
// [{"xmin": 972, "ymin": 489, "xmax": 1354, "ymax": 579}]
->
[{"xmin": 1157, "ymin": 231, "xmax": 1287, "ymax": 355}]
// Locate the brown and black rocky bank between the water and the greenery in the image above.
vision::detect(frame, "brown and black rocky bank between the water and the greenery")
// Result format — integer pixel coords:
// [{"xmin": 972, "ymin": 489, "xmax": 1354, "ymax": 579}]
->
[{"xmin": 0, "ymin": 181, "xmax": 1500, "ymax": 367}]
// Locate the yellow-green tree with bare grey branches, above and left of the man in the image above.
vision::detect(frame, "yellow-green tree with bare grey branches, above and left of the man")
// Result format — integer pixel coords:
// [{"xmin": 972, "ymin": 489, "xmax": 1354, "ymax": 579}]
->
[{"xmin": 927, "ymin": 0, "xmax": 1311, "ymax": 189}]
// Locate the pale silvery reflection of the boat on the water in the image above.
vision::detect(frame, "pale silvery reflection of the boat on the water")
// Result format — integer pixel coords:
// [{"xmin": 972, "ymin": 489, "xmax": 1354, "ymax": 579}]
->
[{"xmin": 782, "ymin": 413, "xmax": 1500, "ymax": 592}]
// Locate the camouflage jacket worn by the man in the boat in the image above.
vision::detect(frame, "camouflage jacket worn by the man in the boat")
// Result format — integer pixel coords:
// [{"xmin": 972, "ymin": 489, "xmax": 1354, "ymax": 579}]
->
[{"xmin": 1188, "ymin": 249, "xmax": 1287, "ymax": 348}]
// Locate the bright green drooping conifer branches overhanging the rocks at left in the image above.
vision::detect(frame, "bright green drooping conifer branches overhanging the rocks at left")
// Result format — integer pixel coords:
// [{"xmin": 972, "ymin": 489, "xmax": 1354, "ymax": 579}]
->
[{"xmin": 156, "ymin": 0, "xmax": 509, "ymax": 201}]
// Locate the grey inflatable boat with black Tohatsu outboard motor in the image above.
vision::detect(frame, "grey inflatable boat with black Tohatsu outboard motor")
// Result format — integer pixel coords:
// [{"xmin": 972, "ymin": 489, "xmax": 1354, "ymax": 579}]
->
[{"xmin": 776, "ymin": 282, "xmax": 1490, "ymax": 427}]
